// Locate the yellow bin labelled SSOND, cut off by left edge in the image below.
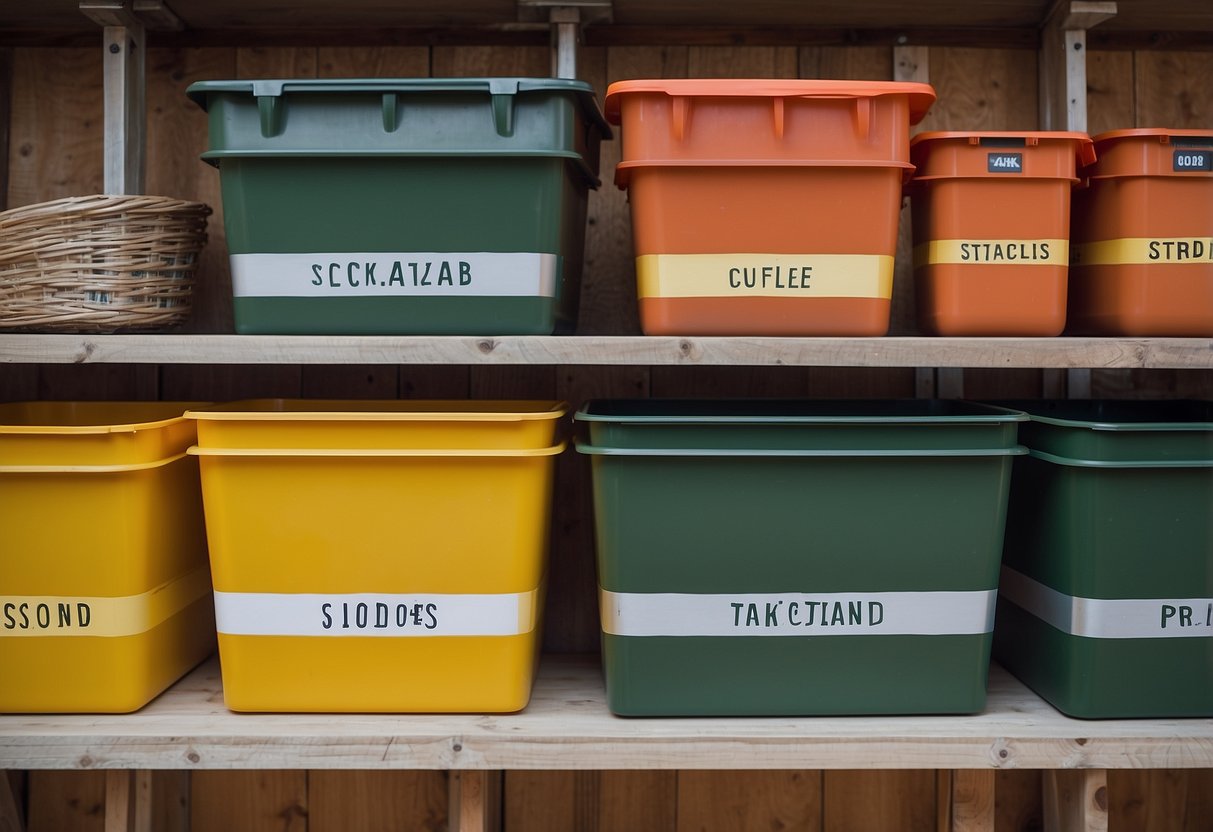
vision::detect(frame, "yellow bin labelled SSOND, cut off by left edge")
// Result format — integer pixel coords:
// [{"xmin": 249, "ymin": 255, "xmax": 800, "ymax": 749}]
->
[{"xmin": 0, "ymin": 401, "xmax": 215, "ymax": 713}]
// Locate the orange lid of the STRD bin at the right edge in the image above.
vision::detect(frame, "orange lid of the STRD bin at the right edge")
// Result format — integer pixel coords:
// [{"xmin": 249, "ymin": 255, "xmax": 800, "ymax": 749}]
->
[{"xmin": 1082, "ymin": 127, "xmax": 1213, "ymax": 178}]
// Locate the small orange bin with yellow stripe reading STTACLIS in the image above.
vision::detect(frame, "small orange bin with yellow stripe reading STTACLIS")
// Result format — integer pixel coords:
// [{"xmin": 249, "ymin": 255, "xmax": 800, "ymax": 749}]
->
[{"xmin": 910, "ymin": 132, "xmax": 1095, "ymax": 336}]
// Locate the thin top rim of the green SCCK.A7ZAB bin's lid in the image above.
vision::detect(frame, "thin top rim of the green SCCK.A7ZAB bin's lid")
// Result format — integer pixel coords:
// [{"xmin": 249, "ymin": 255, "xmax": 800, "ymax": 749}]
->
[{"xmin": 186, "ymin": 76, "xmax": 613, "ymax": 138}]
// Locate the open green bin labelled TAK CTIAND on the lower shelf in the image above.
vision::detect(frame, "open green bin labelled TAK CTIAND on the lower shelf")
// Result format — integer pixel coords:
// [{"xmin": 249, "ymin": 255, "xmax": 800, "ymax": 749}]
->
[{"xmin": 576, "ymin": 401, "xmax": 1025, "ymax": 716}]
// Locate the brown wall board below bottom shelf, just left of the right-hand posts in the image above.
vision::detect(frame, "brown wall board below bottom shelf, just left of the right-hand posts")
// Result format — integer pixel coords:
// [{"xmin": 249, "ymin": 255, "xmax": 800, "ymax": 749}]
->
[{"xmin": 824, "ymin": 771, "xmax": 936, "ymax": 832}]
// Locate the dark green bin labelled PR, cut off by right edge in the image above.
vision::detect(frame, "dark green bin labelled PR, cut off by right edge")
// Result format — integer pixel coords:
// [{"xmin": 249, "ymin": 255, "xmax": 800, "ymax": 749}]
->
[{"xmin": 995, "ymin": 401, "xmax": 1213, "ymax": 718}]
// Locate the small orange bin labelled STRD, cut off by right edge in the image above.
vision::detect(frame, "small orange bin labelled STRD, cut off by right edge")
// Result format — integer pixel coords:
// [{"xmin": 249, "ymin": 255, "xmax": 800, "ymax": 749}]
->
[{"xmin": 1070, "ymin": 129, "xmax": 1213, "ymax": 337}]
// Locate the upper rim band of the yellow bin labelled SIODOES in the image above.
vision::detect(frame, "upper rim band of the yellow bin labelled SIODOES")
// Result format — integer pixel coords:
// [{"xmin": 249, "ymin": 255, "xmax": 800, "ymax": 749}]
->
[{"xmin": 187, "ymin": 399, "xmax": 566, "ymax": 449}]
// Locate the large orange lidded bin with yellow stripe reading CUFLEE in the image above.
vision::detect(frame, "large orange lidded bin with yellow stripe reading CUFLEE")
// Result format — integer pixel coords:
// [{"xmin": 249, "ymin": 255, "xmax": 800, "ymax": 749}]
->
[{"xmin": 605, "ymin": 79, "xmax": 935, "ymax": 336}]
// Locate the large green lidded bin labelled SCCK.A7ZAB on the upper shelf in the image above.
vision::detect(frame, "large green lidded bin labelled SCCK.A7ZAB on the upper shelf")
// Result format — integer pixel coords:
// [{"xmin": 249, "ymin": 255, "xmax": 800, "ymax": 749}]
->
[{"xmin": 187, "ymin": 78, "xmax": 611, "ymax": 335}]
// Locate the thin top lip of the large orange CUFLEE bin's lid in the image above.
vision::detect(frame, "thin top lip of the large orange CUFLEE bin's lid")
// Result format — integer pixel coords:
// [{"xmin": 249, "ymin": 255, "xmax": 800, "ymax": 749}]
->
[{"xmin": 604, "ymin": 78, "xmax": 935, "ymax": 124}]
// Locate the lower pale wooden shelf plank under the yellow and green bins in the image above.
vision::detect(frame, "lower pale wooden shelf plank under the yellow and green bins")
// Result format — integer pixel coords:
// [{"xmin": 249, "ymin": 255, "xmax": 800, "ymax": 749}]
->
[{"xmin": 0, "ymin": 656, "xmax": 1213, "ymax": 770}]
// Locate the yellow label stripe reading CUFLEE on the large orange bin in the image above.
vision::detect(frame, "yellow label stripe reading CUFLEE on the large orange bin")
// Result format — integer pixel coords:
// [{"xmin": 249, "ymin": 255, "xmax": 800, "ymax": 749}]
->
[{"xmin": 636, "ymin": 259, "xmax": 893, "ymax": 304}]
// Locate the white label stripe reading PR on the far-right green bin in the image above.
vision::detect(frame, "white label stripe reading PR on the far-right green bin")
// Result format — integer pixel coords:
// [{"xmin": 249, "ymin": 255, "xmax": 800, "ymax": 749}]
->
[{"xmin": 1000, "ymin": 566, "xmax": 1213, "ymax": 638}]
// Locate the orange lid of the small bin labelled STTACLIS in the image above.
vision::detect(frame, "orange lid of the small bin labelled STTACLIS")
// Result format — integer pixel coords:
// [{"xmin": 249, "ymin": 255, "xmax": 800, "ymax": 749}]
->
[{"xmin": 910, "ymin": 130, "xmax": 1095, "ymax": 181}]
